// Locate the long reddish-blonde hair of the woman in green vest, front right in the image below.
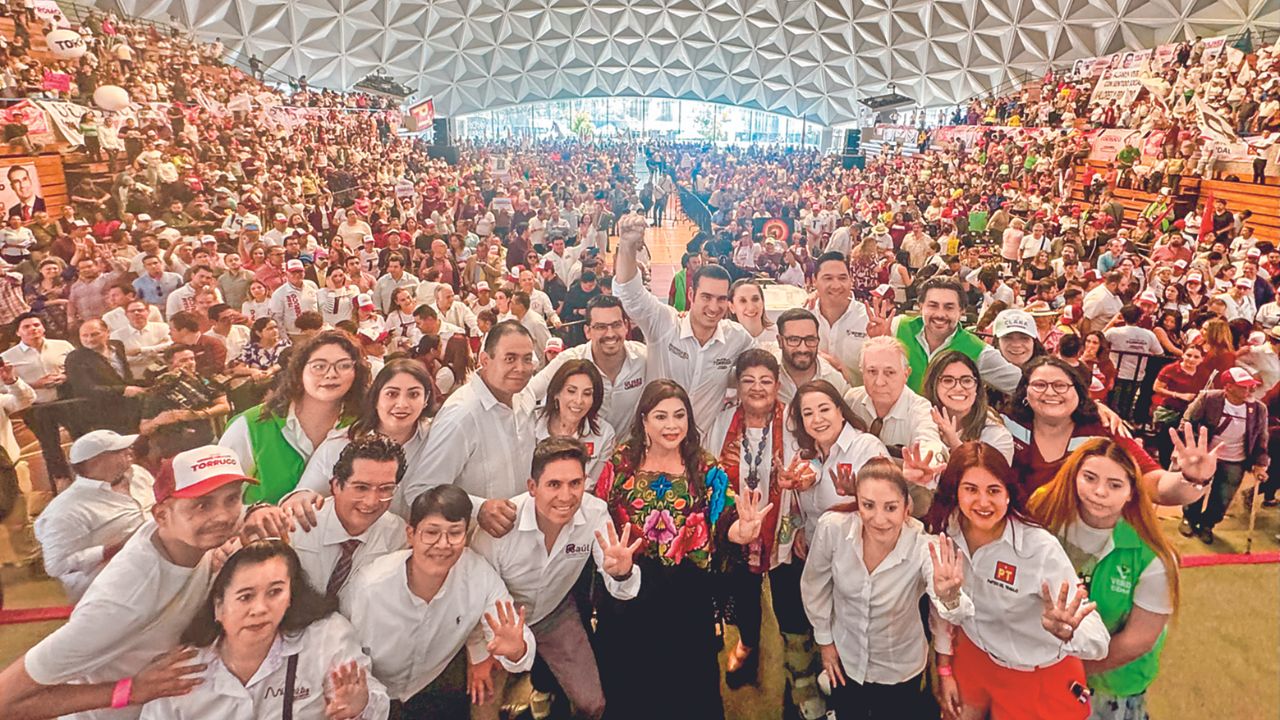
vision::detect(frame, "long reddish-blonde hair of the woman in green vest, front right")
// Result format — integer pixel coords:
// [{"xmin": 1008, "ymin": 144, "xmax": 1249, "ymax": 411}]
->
[{"xmin": 1027, "ymin": 438, "xmax": 1179, "ymax": 610}]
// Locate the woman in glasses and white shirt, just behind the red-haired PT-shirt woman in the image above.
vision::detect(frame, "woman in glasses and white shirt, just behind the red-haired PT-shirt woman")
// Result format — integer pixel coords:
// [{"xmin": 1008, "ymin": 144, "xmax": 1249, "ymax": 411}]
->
[{"xmin": 923, "ymin": 350, "xmax": 1014, "ymax": 462}]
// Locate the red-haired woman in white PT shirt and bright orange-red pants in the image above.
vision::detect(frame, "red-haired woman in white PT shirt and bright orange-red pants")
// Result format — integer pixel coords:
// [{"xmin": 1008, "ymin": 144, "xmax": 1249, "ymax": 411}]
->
[{"xmin": 925, "ymin": 442, "xmax": 1111, "ymax": 720}]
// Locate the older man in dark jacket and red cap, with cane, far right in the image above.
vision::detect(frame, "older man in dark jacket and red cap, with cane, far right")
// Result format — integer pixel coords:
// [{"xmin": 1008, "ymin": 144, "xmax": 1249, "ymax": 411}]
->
[{"xmin": 1178, "ymin": 368, "xmax": 1271, "ymax": 544}]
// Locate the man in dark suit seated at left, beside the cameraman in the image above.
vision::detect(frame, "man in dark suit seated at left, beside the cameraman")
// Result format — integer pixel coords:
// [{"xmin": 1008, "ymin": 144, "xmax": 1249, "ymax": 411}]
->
[{"xmin": 67, "ymin": 320, "xmax": 146, "ymax": 434}]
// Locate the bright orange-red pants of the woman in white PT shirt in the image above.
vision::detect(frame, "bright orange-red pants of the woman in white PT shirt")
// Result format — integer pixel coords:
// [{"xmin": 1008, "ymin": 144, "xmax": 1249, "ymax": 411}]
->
[{"xmin": 952, "ymin": 629, "xmax": 1089, "ymax": 720}]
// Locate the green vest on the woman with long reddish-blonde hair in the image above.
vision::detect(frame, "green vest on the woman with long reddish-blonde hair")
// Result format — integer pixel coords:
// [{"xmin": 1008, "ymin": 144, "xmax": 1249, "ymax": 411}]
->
[{"xmin": 1089, "ymin": 520, "xmax": 1165, "ymax": 697}]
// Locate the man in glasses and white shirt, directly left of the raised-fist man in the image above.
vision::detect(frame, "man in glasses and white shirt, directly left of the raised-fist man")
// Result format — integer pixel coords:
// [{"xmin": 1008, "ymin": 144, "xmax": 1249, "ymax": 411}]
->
[{"xmin": 529, "ymin": 295, "xmax": 649, "ymax": 438}]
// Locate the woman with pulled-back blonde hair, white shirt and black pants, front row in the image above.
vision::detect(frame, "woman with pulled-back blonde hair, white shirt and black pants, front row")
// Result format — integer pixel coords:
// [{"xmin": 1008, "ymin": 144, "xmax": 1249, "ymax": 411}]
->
[{"xmin": 800, "ymin": 457, "xmax": 973, "ymax": 720}]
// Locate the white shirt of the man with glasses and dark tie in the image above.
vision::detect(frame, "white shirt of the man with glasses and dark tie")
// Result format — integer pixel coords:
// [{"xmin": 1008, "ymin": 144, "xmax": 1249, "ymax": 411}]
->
[{"xmin": 289, "ymin": 502, "xmax": 408, "ymax": 594}]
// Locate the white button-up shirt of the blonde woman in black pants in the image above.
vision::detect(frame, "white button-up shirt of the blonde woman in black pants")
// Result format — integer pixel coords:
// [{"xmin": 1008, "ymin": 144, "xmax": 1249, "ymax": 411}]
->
[{"xmin": 800, "ymin": 512, "xmax": 974, "ymax": 685}]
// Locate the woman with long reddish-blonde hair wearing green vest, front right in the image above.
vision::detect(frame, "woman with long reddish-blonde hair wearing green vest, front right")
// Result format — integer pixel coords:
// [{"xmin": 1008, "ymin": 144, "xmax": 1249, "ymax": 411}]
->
[{"xmin": 1028, "ymin": 438, "xmax": 1179, "ymax": 720}]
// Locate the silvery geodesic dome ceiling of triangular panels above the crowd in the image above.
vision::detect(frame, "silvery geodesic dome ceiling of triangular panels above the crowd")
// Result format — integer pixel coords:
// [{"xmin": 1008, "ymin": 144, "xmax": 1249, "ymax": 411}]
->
[{"xmin": 112, "ymin": 0, "xmax": 1280, "ymax": 124}]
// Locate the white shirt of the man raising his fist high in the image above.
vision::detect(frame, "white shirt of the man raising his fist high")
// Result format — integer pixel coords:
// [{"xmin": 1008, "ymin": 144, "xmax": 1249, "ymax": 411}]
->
[{"xmin": 613, "ymin": 274, "xmax": 755, "ymax": 430}]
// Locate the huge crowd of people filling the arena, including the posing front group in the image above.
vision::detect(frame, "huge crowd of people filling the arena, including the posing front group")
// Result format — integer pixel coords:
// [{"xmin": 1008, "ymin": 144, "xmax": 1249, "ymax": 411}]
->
[{"xmin": 0, "ymin": 4, "xmax": 1280, "ymax": 720}]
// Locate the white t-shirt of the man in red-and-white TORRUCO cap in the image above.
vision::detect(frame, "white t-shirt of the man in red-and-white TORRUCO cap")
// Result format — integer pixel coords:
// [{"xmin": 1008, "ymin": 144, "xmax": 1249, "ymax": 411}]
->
[{"xmin": 24, "ymin": 521, "xmax": 214, "ymax": 720}]
